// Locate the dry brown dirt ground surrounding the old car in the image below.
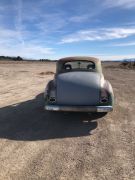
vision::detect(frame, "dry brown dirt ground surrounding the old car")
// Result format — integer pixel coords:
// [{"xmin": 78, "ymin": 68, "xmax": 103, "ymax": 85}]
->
[{"xmin": 0, "ymin": 62, "xmax": 135, "ymax": 180}]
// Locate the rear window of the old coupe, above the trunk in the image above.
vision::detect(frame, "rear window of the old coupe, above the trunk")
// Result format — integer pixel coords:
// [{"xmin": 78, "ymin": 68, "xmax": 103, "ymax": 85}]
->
[{"xmin": 62, "ymin": 61, "xmax": 96, "ymax": 71}]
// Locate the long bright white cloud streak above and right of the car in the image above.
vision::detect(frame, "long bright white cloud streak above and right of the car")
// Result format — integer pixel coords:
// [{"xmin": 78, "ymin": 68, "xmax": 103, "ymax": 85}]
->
[{"xmin": 60, "ymin": 28, "xmax": 135, "ymax": 44}]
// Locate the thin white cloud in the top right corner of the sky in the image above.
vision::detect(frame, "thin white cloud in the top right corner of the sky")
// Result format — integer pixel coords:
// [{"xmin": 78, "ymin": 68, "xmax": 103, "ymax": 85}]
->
[{"xmin": 103, "ymin": 0, "xmax": 135, "ymax": 9}]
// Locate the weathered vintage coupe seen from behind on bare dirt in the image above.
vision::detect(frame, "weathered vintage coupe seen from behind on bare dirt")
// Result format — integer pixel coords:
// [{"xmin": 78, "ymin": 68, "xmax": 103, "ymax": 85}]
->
[{"xmin": 44, "ymin": 56, "xmax": 114, "ymax": 112}]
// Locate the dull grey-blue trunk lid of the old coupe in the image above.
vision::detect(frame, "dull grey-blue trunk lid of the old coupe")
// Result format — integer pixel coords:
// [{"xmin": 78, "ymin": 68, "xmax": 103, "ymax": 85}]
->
[{"xmin": 56, "ymin": 71, "xmax": 100, "ymax": 105}]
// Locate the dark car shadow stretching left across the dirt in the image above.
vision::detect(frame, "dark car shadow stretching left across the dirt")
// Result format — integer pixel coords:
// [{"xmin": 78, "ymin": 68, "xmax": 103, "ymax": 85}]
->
[{"xmin": 0, "ymin": 94, "xmax": 106, "ymax": 141}]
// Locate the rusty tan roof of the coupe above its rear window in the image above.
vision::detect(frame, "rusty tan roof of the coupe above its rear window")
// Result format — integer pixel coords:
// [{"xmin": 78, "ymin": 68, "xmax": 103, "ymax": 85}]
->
[{"xmin": 58, "ymin": 56, "xmax": 100, "ymax": 63}]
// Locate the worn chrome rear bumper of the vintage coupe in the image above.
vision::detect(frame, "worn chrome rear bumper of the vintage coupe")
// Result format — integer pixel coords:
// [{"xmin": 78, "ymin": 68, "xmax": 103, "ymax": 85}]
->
[{"xmin": 45, "ymin": 105, "xmax": 113, "ymax": 112}]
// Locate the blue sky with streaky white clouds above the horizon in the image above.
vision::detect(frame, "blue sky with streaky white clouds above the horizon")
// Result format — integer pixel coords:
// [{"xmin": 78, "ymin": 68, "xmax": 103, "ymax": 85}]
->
[{"xmin": 0, "ymin": 0, "xmax": 135, "ymax": 60}]
